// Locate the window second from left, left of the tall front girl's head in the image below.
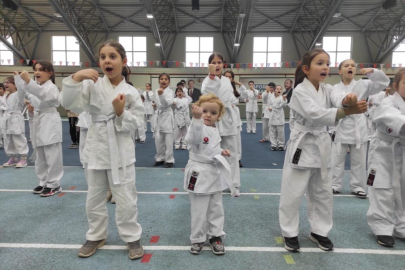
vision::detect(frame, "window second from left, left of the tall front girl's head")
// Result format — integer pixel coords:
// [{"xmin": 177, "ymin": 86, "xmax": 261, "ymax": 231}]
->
[{"xmin": 52, "ymin": 36, "xmax": 80, "ymax": 66}]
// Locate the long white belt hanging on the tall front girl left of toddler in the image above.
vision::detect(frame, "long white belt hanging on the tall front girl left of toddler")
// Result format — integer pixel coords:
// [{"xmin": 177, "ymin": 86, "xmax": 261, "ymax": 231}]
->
[{"xmin": 91, "ymin": 113, "xmax": 126, "ymax": 185}]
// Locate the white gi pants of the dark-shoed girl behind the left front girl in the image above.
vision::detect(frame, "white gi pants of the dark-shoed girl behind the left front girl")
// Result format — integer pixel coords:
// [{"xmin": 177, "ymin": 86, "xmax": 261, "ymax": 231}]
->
[{"xmin": 35, "ymin": 143, "xmax": 63, "ymax": 188}]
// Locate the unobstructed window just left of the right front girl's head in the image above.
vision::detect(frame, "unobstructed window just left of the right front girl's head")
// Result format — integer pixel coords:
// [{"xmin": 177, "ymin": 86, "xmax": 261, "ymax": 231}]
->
[{"xmin": 253, "ymin": 37, "xmax": 282, "ymax": 67}]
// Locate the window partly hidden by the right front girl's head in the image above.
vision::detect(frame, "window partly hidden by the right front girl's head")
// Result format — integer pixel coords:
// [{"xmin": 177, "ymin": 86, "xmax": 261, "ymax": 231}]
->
[{"xmin": 322, "ymin": 37, "xmax": 352, "ymax": 66}]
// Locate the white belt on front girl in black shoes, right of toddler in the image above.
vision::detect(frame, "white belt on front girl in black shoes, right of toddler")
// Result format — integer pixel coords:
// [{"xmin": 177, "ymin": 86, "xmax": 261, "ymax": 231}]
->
[{"xmin": 292, "ymin": 122, "xmax": 329, "ymax": 180}]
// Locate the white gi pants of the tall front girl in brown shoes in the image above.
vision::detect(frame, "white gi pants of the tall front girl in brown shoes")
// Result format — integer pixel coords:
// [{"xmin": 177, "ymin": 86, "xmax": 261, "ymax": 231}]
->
[{"xmin": 85, "ymin": 164, "xmax": 142, "ymax": 242}]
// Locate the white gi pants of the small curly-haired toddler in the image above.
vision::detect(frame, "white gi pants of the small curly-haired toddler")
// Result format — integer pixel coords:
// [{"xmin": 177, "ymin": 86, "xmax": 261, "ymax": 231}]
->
[{"xmin": 189, "ymin": 191, "xmax": 226, "ymax": 244}]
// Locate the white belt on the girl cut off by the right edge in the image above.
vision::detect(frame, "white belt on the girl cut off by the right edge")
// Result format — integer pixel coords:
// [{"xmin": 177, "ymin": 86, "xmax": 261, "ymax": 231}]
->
[{"xmin": 375, "ymin": 130, "xmax": 405, "ymax": 213}]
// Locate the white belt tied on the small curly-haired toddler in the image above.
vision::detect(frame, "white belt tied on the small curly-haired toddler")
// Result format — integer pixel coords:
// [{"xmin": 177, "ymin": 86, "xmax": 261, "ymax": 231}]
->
[{"xmin": 189, "ymin": 152, "xmax": 236, "ymax": 197}]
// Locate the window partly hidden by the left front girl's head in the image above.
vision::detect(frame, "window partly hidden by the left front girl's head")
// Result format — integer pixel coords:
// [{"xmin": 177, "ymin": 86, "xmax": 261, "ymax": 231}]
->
[{"xmin": 118, "ymin": 37, "xmax": 146, "ymax": 67}]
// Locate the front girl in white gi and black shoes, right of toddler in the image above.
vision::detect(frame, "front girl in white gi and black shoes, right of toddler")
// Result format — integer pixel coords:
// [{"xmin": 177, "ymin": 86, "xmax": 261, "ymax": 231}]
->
[{"xmin": 279, "ymin": 49, "xmax": 367, "ymax": 252}]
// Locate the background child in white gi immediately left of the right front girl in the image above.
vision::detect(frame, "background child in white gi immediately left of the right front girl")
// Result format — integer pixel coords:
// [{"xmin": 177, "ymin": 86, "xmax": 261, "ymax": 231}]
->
[{"xmin": 269, "ymin": 85, "xmax": 287, "ymax": 151}]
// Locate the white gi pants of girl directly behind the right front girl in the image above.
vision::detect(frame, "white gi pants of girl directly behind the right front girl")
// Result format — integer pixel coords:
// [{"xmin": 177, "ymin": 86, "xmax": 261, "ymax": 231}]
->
[{"xmin": 332, "ymin": 142, "xmax": 367, "ymax": 192}]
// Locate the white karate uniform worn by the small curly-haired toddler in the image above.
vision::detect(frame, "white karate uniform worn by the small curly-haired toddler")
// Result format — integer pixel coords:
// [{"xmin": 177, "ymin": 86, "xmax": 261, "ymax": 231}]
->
[{"xmin": 184, "ymin": 118, "xmax": 235, "ymax": 243}]
